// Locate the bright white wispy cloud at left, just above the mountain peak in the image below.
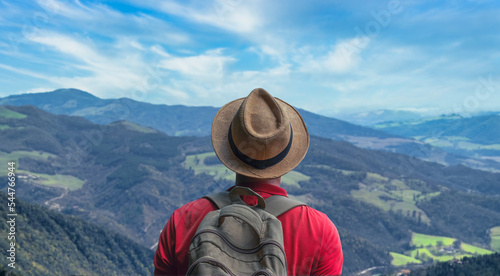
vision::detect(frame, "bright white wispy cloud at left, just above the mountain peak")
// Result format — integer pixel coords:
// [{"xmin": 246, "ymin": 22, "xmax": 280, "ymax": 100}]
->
[{"xmin": 21, "ymin": 32, "xmax": 154, "ymax": 97}]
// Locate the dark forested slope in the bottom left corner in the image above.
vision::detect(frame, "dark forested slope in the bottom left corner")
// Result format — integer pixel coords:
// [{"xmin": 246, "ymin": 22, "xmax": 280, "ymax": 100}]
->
[{"xmin": 0, "ymin": 191, "xmax": 153, "ymax": 275}]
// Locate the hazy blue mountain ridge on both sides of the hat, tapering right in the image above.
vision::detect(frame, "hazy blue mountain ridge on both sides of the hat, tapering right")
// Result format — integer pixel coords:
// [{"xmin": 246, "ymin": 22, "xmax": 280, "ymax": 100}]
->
[{"xmin": 0, "ymin": 89, "xmax": 394, "ymax": 139}]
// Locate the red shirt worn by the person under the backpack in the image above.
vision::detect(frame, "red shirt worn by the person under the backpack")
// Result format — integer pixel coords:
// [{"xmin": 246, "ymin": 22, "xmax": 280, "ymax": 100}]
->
[{"xmin": 154, "ymin": 183, "xmax": 343, "ymax": 275}]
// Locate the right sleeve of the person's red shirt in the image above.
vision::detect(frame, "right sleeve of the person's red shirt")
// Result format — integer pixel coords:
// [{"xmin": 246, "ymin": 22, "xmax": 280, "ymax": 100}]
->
[{"xmin": 313, "ymin": 216, "xmax": 344, "ymax": 275}]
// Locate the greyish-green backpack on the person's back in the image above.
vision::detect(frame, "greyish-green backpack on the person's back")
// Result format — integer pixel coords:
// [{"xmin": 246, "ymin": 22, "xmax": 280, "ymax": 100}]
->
[{"xmin": 186, "ymin": 186, "xmax": 305, "ymax": 276}]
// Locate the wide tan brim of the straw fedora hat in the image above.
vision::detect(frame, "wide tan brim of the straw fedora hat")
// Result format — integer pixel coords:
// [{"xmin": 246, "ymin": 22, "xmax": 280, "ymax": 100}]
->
[{"xmin": 212, "ymin": 98, "xmax": 309, "ymax": 179}]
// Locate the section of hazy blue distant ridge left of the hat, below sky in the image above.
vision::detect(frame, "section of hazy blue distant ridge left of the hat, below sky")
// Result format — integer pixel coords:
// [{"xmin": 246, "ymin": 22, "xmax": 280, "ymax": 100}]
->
[{"xmin": 0, "ymin": 89, "xmax": 217, "ymax": 136}]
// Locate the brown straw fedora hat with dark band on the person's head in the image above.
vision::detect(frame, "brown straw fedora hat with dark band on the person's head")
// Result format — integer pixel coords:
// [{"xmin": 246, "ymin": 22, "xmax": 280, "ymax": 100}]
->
[{"xmin": 212, "ymin": 88, "xmax": 309, "ymax": 179}]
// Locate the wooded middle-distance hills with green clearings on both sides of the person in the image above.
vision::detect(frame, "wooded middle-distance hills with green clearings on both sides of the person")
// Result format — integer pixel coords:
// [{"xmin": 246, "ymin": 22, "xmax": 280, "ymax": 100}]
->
[{"xmin": 0, "ymin": 102, "xmax": 500, "ymax": 275}]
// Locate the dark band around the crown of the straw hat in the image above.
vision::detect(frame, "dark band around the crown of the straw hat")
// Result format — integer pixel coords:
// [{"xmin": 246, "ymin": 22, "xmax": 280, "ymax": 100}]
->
[{"xmin": 227, "ymin": 123, "xmax": 293, "ymax": 170}]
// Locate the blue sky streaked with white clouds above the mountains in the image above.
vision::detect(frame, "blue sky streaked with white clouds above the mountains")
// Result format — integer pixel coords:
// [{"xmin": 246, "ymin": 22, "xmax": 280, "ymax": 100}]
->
[{"xmin": 0, "ymin": 0, "xmax": 500, "ymax": 116}]
